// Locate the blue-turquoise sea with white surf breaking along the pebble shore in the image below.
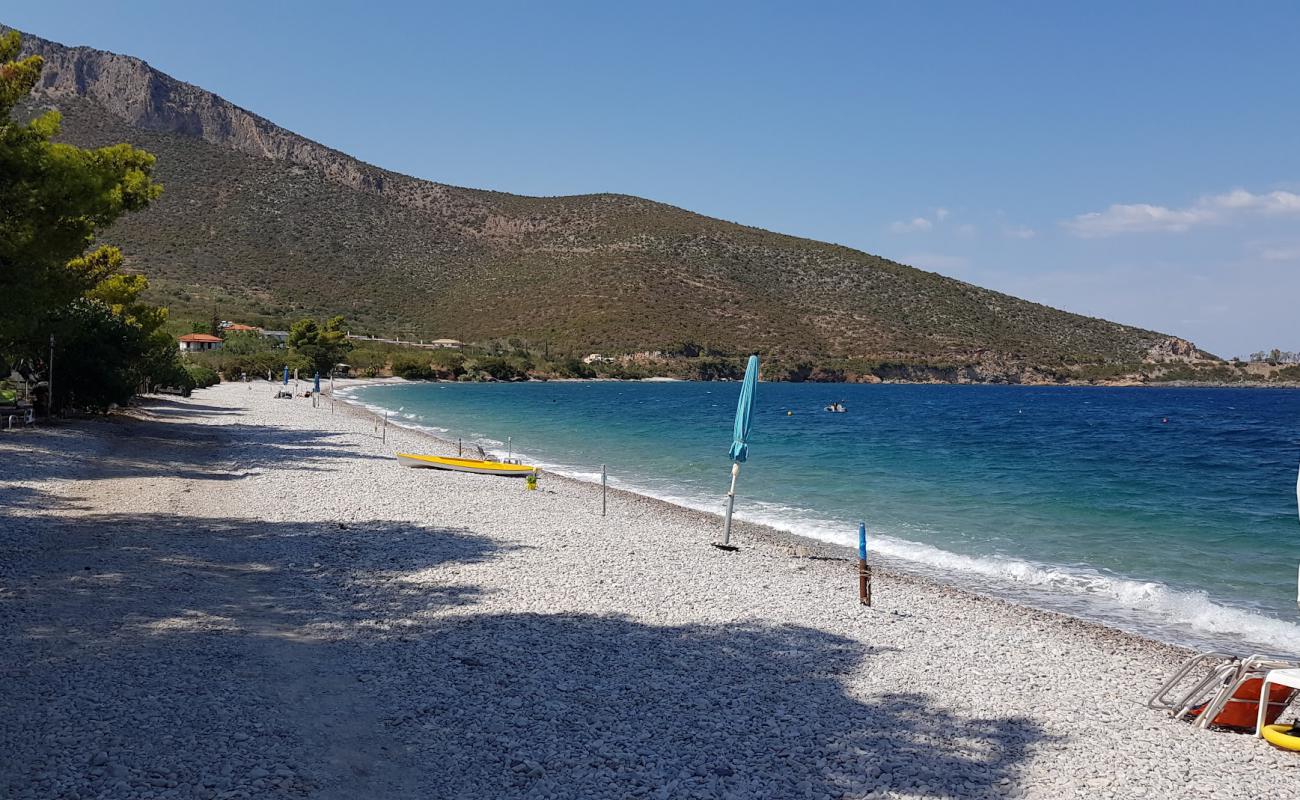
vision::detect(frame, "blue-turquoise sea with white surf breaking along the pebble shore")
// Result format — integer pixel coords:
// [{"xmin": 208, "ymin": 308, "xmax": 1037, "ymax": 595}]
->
[{"xmin": 338, "ymin": 381, "xmax": 1300, "ymax": 653}]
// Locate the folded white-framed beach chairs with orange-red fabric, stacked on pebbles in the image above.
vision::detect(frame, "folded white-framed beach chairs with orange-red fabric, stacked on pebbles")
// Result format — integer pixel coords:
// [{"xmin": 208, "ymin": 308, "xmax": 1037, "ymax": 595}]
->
[{"xmin": 1147, "ymin": 650, "xmax": 1300, "ymax": 731}]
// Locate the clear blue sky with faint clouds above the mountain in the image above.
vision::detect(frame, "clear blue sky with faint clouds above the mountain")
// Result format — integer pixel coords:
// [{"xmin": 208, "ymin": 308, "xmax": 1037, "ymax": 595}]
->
[{"xmin": 12, "ymin": 0, "xmax": 1300, "ymax": 355}]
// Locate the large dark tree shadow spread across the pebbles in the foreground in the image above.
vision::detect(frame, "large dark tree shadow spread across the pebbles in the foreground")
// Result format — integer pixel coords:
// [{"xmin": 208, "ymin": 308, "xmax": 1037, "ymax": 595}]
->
[{"xmin": 0, "ymin": 515, "xmax": 1044, "ymax": 799}]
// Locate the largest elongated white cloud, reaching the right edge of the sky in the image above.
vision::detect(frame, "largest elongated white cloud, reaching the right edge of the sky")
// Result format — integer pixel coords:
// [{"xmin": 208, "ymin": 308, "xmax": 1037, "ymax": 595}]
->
[{"xmin": 1061, "ymin": 189, "xmax": 1300, "ymax": 238}]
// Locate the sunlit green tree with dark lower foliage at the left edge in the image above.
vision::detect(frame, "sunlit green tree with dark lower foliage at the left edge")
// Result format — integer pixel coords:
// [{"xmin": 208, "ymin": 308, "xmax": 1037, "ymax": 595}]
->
[{"xmin": 0, "ymin": 31, "xmax": 170, "ymax": 408}]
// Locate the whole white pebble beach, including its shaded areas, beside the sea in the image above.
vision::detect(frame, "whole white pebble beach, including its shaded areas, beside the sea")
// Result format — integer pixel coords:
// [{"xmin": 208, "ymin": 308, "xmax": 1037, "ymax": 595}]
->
[{"xmin": 0, "ymin": 381, "xmax": 1300, "ymax": 800}]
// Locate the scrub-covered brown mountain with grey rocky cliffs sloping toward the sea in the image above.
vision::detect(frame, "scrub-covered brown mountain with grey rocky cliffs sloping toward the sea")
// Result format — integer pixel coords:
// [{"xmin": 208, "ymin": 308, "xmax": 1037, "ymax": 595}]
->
[{"xmin": 7, "ymin": 26, "xmax": 1213, "ymax": 380}]
